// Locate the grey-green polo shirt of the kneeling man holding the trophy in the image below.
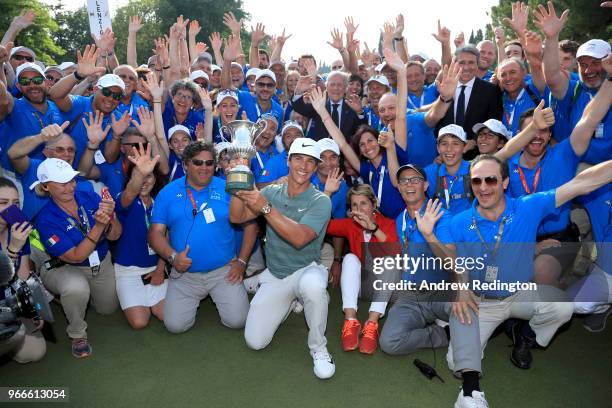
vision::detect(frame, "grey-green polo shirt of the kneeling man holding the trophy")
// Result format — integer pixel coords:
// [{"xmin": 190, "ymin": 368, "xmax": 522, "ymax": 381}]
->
[{"xmin": 261, "ymin": 183, "xmax": 331, "ymax": 279}]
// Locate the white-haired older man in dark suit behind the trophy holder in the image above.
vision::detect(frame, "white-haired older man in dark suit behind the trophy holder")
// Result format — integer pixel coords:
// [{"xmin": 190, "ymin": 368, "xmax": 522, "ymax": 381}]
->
[{"xmin": 293, "ymin": 71, "xmax": 366, "ymax": 142}]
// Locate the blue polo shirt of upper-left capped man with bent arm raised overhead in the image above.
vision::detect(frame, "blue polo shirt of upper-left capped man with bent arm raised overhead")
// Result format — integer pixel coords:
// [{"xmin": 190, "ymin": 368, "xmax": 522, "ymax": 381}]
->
[{"xmin": 64, "ymin": 95, "xmax": 121, "ymax": 167}]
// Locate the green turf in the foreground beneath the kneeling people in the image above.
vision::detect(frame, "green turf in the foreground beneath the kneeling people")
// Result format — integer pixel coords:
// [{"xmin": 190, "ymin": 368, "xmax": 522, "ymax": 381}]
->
[{"xmin": 0, "ymin": 290, "xmax": 612, "ymax": 408}]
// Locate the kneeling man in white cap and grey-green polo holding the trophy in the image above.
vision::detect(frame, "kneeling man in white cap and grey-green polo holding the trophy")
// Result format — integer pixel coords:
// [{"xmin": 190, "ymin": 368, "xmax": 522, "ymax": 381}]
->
[{"xmin": 227, "ymin": 127, "xmax": 335, "ymax": 379}]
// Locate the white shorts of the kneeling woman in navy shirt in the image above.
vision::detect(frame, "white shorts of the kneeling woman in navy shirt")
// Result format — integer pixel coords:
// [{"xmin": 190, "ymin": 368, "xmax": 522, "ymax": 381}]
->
[{"xmin": 115, "ymin": 264, "xmax": 168, "ymax": 310}]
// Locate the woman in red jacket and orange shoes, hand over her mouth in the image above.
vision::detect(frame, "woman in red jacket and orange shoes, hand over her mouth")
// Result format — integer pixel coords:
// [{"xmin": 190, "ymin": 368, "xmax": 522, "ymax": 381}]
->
[{"xmin": 327, "ymin": 184, "xmax": 399, "ymax": 354}]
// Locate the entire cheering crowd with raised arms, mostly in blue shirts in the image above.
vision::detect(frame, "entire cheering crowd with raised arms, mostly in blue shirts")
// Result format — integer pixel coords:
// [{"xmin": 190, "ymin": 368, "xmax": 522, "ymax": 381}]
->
[{"xmin": 0, "ymin": 2, "xmax": 612, "ymax": 407}]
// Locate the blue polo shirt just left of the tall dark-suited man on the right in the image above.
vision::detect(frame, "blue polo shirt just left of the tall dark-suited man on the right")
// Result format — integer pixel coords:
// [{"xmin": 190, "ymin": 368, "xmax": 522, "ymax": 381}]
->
[{"xmin": 406, "ymin": 109, "xmax": 438, "ymax": 167}]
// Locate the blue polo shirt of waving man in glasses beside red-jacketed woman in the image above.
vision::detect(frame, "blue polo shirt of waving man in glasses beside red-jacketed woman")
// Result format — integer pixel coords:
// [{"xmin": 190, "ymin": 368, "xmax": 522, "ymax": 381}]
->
[{"xmin": 395, "ymin": 202, "xmax": 454, "ymax": 287}]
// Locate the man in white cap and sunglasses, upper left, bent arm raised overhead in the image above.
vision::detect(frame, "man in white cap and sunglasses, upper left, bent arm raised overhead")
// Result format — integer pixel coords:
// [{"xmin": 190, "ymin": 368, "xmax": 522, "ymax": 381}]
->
[{"xmin": 49, "ymin": 45, "xmax": 129, "ymax": 163}]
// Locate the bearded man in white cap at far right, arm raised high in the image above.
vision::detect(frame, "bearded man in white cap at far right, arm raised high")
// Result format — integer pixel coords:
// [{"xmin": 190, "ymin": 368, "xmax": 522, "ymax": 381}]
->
[{"xmin": 535, "ymin": 2, "xmax": 612, "ymax": 164}]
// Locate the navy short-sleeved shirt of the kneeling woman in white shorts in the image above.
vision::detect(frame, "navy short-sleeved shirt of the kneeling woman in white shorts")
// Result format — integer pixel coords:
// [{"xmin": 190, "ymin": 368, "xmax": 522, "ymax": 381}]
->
[{"xmin": 113, "ymin": 193, "xmax": 159, "ymax": 268}]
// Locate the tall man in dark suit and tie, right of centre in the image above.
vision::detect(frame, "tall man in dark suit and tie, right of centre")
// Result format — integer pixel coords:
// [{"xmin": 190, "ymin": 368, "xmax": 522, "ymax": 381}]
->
[{"xmin": 438, "ymin": 45, "xmax": 503, "ymax": 152}]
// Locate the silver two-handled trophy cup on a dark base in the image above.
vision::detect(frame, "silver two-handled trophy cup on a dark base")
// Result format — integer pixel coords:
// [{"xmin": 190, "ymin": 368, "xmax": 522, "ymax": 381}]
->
[{"xmin": 221, "ymin": 119, "xmax": 268, "ymax": 194}]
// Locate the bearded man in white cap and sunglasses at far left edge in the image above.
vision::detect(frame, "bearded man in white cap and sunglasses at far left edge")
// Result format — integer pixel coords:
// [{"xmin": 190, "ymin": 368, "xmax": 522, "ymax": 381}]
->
[{"xmin": 0, "ymin": 59, "xmax": 65, "ymax": 170}]
